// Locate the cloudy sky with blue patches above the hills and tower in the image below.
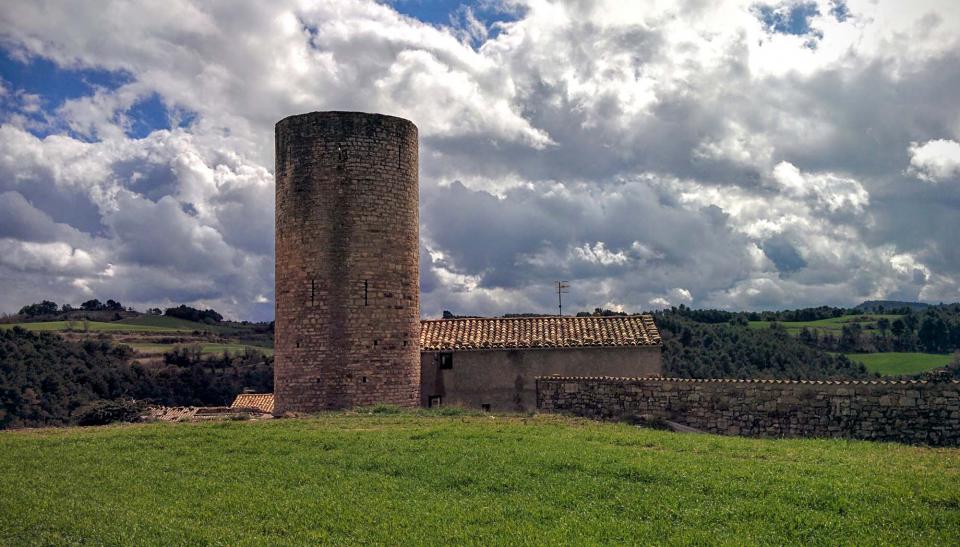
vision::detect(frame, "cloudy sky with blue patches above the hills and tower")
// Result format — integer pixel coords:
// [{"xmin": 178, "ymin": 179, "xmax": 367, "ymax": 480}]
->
[{"xmin": 0, "ymin": 0, "xmax": 960, "ymax": 320}]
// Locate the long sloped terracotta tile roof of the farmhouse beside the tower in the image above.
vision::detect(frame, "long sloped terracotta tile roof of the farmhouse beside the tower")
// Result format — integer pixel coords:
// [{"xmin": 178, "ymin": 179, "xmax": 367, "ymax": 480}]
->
[{"xmin": 420, "ymin": 315, "xmax": 660, "ymax": 351}]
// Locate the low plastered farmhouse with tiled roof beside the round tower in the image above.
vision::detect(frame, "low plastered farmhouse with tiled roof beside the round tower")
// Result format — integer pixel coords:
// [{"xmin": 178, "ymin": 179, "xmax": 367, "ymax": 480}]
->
[{"xmin": 420, "ymin": 315, "xmax": 662, "ymax": 412}]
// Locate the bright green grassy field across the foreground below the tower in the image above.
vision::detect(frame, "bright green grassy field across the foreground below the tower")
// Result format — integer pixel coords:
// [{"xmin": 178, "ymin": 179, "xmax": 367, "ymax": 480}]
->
[{"xmin": 0, "ymin": 414, "xmax": 960, "ymax": 545}]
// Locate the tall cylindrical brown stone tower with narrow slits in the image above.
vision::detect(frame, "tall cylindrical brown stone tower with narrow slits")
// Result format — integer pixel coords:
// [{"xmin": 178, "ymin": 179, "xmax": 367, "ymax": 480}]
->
[{"xmin": 274, "ymin": 112, "xmax": 420, "ymax": 413}]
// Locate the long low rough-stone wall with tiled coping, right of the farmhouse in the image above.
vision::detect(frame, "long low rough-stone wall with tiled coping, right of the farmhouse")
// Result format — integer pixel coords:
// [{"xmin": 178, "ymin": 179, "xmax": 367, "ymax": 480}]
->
[{"xmin": 537, "ymin": 376, "xmax": 960, "ymax": 446}]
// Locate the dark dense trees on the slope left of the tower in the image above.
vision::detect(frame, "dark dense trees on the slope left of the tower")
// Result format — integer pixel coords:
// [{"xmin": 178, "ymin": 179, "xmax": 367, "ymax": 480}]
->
[{"xmin": 0, "ymin": 327, "xmax": 273, "ymax": 429}]
